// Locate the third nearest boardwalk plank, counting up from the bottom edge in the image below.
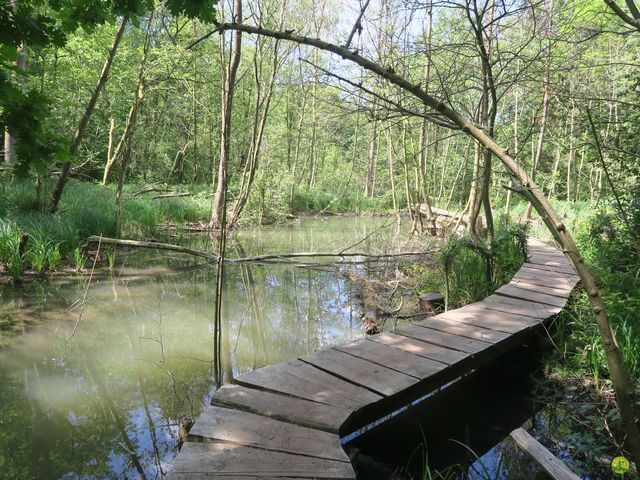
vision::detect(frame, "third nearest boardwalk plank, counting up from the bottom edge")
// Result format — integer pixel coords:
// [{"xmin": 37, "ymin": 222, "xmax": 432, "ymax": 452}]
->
[{"xmin": 212, "ymin": 385, "xmax": 351, "ymax": 433}]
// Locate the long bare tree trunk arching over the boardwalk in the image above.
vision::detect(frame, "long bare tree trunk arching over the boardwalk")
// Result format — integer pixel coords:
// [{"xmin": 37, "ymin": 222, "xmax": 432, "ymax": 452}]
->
[{"xmin": 189, "ymin": 23, "xmax": 640, "ymax": 465}]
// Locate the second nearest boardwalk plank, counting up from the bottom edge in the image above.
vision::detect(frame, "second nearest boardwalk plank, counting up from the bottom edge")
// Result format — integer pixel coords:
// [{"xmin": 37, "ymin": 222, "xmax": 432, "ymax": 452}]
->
[{"xmin": 189, "ymin": 406, "xmax": 349, "ymax": 462}]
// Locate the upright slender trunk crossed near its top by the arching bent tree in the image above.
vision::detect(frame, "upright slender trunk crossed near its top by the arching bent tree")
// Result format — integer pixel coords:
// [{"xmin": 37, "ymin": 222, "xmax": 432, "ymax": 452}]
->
[{"xmin": 209, "ymin": 0, "xmax": 242, "ymax": 229}]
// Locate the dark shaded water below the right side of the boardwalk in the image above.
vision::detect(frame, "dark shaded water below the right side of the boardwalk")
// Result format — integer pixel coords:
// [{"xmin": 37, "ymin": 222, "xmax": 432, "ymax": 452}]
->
[{"xmin": 347, "ymin": 337, "xmax": 544, "ymax": 480}]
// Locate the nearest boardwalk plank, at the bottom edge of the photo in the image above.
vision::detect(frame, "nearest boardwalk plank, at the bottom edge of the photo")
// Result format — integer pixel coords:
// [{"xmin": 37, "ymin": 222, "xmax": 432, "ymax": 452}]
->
[{"xmin": 169, "ymin": 442, "xmax": 355, "ymax": 480}]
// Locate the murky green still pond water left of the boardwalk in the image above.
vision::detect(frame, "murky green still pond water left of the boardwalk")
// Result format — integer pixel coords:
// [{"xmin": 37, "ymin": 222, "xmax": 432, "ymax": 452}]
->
[{"xmin": 0, "ymin": 217, "xmax": 427, "ymax": 479}]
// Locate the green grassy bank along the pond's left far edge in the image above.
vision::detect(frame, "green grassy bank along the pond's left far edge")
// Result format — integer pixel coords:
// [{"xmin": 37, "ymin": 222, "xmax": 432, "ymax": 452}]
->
[{"xmin": 0, "ymin": 181, "xmax": 211, "ymax": 279}]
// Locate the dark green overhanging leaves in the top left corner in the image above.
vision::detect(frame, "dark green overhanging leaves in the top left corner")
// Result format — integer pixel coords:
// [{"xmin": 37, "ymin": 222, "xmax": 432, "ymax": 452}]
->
[{"xmin": 0, "ymin": 0, "xmax": 217, "ymax": 178}]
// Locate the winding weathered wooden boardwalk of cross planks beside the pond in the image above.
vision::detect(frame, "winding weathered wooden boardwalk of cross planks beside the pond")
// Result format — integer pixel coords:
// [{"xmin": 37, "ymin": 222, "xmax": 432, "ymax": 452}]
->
[{"xmin": 169, "ymin": 242, "xmax": 579, "ymax": 480}]
